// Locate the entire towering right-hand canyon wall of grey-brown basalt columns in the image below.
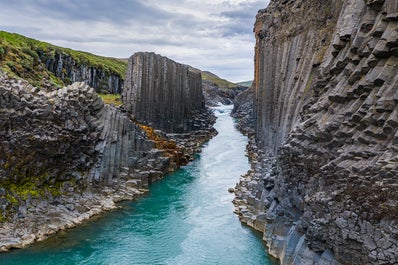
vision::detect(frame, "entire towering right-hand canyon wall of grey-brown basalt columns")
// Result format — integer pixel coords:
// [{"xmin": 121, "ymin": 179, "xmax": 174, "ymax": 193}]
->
[{"xmin": 235, "ymin": 0, "xmax": 398, "ymax": 264}]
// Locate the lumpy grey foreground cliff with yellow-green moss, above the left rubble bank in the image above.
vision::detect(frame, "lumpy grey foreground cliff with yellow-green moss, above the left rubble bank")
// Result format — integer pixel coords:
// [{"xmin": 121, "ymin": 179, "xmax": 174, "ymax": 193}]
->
[{"xmin": 0, "ymin": 72, "xmax": 153, "ymax": 210}]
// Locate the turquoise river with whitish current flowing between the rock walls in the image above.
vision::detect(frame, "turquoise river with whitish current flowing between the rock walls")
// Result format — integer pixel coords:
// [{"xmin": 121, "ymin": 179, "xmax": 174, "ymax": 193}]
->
[{"xmin": 0, "ymin": 106, "xmax": 275, "ymax": 265}]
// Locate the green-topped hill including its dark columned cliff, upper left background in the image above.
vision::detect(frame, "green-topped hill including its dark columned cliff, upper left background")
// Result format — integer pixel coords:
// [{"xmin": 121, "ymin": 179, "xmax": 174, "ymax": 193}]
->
[{"xmin": 0, "ymin": 31, "xmax": 127, "ymax": 91}]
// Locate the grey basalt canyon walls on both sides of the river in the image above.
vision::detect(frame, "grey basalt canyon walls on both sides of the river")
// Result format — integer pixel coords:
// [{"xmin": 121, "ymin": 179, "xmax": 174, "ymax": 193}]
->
[{"xmin": 0, "ymin": 0, "xmax": 398, "ymax": 265}]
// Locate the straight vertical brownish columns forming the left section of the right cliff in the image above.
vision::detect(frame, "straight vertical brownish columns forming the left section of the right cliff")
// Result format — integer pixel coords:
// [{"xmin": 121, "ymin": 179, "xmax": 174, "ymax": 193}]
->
[{"xmin": 253, "ymin": 1, "xmax": 342, "ymax": 151}]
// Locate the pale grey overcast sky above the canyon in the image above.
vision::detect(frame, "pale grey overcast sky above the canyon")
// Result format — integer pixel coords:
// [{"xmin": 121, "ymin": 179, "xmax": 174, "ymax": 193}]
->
[{"xmin": 0, "ymin": 0, "xmax": 268, "ymax": 82}]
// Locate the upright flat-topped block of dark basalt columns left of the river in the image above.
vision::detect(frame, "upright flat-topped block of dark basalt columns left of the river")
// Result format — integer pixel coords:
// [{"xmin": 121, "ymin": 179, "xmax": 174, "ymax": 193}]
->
[{"xmin": 122, "ymin": 52, "xmax": 205, "ymax": 132}]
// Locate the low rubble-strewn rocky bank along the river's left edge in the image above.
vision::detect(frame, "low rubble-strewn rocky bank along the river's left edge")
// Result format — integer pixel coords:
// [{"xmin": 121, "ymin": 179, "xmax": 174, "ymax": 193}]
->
[{"xmin": 0, "ymin": 124, "xmax": 216, "ymax": 252}]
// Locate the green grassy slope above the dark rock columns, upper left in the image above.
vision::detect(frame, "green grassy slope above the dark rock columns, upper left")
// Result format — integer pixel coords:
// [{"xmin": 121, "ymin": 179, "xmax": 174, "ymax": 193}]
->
[{"xmin": 0, "ymin": 31, "xmax": 127, "ymax": 86}]
